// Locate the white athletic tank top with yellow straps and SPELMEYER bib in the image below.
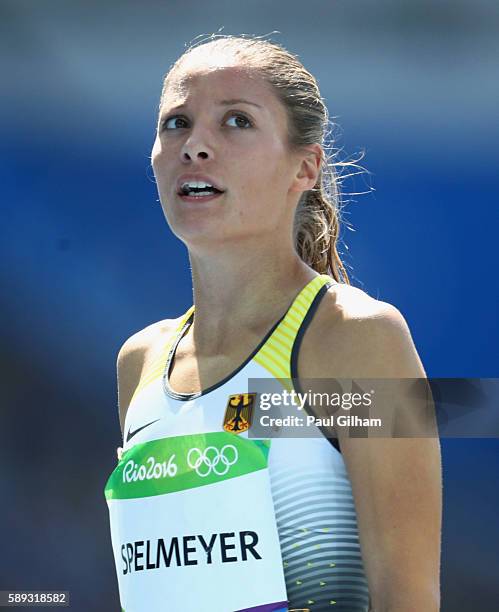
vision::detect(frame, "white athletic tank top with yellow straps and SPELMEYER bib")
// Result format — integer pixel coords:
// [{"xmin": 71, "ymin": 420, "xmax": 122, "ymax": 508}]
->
[{"xmin": 105, "ymin": 275, "xmax": 369, "ymax": 612}]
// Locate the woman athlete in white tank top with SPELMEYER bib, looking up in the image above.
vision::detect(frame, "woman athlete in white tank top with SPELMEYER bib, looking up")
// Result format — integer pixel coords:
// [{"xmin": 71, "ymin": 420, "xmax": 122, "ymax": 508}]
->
[{"xmin": 106, "ymin": 36, "xmax": 441, "ymax": 612}]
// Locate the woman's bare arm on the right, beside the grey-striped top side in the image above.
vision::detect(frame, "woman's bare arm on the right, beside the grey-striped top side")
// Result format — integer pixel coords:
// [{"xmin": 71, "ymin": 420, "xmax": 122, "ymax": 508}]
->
[{"xmin": 320, "ymin": 303, "xmax": 442, "ymax": 612}]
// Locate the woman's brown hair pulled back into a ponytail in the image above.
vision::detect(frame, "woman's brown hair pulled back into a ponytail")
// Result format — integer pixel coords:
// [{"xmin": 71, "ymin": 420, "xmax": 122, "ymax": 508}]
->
[{"xmin": 160, "ymin": 34, "xmax": 372, "ymax": 284}]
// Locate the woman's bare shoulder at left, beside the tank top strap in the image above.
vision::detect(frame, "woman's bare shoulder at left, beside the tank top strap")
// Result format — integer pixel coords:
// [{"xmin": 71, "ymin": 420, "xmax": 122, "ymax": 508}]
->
[{"xmin": 116, "ymin": 318, "xmax": 180, "ymax": 431}]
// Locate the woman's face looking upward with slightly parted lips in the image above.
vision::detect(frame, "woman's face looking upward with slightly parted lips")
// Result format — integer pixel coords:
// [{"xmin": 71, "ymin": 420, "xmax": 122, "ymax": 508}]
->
[{"xmin": 152, "ymin": 61, "xmax": 313, "ymax": 246}]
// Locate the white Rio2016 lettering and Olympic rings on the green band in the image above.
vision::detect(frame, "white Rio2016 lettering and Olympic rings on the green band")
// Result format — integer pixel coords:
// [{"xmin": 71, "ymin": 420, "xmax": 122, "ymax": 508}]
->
[{"xmin": 123, "ymin": 444, "xmax": 239, "ymax": 483}]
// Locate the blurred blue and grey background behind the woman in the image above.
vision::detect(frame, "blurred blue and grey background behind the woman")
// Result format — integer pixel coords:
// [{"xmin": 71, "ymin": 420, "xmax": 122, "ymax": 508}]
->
[{"xmin": 0, "ymin": 0, "xmax": 499, "ymax": 612}]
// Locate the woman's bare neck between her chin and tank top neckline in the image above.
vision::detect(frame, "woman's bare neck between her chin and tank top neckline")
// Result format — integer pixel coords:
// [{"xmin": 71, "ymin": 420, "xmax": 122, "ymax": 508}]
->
[{"xmin": 189, "ymin": 239, "xmax": 317, "ymax": 355}]
